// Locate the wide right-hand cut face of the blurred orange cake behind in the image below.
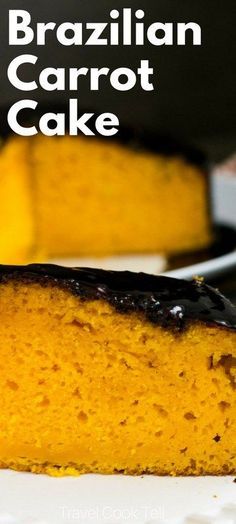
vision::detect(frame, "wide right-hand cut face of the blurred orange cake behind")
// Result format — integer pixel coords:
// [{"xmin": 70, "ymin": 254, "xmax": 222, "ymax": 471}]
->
[{"xmin": 30, "ymin": 137, "xmax": 210, "ymax": 257}]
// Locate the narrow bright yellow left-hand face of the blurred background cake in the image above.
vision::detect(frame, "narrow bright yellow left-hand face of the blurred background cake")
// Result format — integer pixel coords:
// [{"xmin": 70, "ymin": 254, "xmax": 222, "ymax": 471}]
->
[{"xmin": 0, "ymin": 138, "xmax": 35, "ymax": 264}]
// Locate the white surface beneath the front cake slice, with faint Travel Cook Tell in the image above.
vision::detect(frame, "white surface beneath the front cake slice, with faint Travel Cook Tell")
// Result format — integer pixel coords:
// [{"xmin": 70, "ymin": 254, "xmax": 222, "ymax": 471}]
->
[{"xmin": 0, "ymin": 471, "xmax": 236, "ymax": 524}]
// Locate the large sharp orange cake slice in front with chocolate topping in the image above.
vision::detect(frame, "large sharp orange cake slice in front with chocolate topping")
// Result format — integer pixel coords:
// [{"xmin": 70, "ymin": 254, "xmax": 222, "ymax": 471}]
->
[{"xmin": 0, "ymin": 265, "xmax": 236, "ymax": 475}]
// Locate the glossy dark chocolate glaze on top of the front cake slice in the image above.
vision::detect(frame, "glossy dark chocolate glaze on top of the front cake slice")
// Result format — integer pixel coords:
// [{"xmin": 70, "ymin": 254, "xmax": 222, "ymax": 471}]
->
[{"xmin": 0, "ymin": 264, "xmax": 236, "ymax": 330}]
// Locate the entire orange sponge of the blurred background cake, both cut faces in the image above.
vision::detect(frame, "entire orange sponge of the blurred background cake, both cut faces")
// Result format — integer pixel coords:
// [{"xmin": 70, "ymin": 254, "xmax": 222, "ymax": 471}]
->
[{"xmin": 0, "ymin": 132, "xmax": 211, "ymax": 263}]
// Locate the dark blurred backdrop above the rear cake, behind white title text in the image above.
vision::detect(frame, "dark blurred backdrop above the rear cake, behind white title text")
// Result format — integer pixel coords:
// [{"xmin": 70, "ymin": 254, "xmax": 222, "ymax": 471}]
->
[{"xmin": 0, "ymin": 0, "xmax": 236, "ymax": 160}]
